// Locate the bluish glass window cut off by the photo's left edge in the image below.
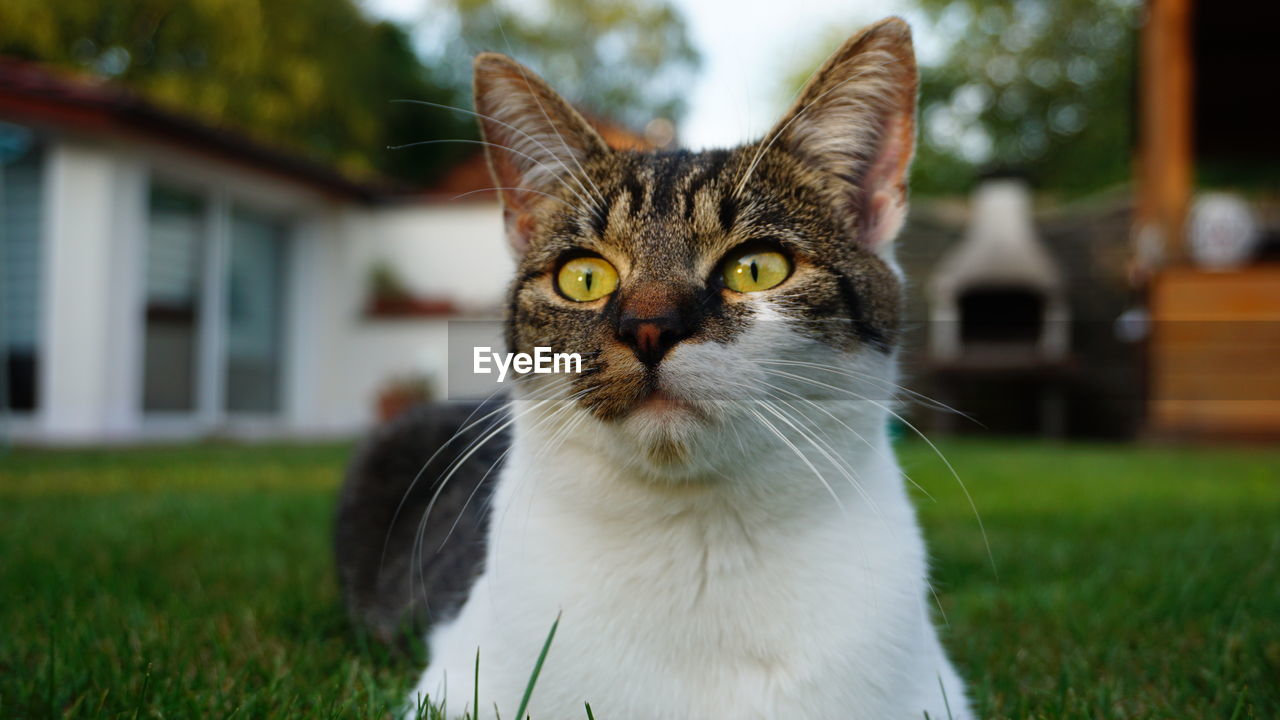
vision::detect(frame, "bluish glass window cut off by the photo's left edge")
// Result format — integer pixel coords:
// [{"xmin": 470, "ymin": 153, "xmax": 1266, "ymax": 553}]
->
[{"xmin": 0, "ymin": 133, "xmax": 44, "ymax": 411}]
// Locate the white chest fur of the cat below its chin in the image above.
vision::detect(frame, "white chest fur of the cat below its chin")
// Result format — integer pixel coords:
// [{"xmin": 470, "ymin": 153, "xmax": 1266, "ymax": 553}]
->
[{"xmin": 415, "ymin": 409, "xmax": 969, "ymax": 720}]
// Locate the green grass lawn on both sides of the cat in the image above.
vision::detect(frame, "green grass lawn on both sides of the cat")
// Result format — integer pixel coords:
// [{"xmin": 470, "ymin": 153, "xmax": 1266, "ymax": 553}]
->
[{"xmin": 0, "ymin": 441, "xmax": 1280, "ymax": 720}]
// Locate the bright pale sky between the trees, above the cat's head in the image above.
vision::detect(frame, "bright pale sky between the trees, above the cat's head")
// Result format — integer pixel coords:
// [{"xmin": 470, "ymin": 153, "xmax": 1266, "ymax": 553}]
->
[{"xmin": 362, "ymin": 0, "xmax": 941, "ymax": 150}]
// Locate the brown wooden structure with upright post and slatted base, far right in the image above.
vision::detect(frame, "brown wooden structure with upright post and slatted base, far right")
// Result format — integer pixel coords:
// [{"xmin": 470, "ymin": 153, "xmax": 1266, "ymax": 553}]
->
[{"xmin": 1132, "ymin": 0, "xmax": 1280, "ymax": 437}]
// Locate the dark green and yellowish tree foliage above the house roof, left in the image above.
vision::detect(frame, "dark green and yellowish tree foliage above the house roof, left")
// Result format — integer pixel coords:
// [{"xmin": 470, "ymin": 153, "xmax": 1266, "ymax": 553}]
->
[{"xmin": 0, "ymin": 0, "xmax": 470, "ymax": 181}]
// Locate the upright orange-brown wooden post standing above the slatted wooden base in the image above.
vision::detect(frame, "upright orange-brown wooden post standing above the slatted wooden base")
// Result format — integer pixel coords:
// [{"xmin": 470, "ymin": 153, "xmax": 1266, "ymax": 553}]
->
[{"xmin": 1137, "ymin": 0, "xmax": 1193, "ymax": 269}]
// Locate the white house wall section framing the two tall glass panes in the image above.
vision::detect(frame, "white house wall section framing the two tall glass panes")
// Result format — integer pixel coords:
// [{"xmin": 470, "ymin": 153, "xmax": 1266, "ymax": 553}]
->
[{"xmin": 4, "ymin": 128, "xmax": 348, "ymax": 443}]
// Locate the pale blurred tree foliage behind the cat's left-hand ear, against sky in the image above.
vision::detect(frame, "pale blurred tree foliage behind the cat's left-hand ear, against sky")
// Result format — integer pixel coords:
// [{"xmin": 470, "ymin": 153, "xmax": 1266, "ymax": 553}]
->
[{"xmin": 431, "ymin": 0, "xmax": 699, "ymax": 128}]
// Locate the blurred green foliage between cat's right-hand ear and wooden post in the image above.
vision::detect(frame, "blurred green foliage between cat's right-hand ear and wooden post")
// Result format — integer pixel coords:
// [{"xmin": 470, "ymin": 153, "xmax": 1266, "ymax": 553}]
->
[{"xmin": 792, "ymin": 0, "xmax": 1139, "ymax": 196}]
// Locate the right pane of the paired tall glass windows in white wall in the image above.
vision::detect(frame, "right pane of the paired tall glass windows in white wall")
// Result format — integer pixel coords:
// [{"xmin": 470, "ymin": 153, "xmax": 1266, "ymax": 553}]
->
[{"xmin": 225, "ymin": 209, "xmax": 287, "ymax": 413}]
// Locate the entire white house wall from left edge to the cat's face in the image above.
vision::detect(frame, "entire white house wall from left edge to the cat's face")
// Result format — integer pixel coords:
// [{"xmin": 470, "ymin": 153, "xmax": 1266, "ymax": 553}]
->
[{"xmin": 0, "ymin": 117, "xmax": 513, "ymax": 443}]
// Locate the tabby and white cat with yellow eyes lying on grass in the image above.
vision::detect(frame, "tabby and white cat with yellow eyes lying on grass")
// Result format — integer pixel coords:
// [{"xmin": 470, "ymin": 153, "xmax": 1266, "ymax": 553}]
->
[{"xmin": 337, "ymin": 18, "xmax": 973, "ymax": 720}]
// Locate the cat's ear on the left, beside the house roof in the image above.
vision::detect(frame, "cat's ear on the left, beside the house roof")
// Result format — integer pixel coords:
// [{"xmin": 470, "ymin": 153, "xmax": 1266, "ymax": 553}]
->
[{"xmin": 474, "ymin": 53, "xmax": 608, "ymax": 254}]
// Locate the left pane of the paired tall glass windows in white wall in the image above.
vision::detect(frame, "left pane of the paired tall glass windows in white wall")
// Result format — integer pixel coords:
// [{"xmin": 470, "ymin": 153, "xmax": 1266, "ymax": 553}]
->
[{"xmin": 142, "ymin": 187, "xmax": 206, "ymax": 413}]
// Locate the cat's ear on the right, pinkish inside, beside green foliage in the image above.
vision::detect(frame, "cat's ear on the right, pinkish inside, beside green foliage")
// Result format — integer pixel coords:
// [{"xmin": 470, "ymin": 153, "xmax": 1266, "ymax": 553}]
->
[{"xmin": 769, "ymin": 18, "xmax": 919, "ymax": 252}]
